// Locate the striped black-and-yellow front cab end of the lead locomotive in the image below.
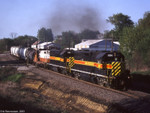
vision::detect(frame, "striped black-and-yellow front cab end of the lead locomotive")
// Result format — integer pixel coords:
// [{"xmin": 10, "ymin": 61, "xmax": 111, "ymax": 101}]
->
[{"xmin": 97, "ymin": 51, "xmax": 130, "ymax": 89}]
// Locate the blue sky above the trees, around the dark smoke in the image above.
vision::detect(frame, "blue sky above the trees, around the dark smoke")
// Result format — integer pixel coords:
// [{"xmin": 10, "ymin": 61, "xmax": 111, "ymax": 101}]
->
[{"xmin": 0, "ymin": 0, "xmax": 150, "ymax": 38}]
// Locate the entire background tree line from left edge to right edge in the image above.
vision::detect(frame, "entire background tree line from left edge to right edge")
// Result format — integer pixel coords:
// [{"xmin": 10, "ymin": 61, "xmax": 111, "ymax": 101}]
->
[{"xmin": 0, "ymin": 12, "xmax": 150, "ymax": 70}]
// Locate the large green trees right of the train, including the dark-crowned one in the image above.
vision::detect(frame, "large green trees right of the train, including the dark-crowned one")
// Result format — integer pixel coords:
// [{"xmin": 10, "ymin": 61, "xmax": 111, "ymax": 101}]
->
[{"xmin": 105, "ymin": 12, "xmax": 150, "ymax": 70}]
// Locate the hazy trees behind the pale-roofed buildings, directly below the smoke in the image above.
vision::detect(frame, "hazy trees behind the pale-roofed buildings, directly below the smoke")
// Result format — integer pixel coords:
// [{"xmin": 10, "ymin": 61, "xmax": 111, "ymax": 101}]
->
[{"xmin": 37, "ymin": 27, "xmax": 100, "ymax": 49}]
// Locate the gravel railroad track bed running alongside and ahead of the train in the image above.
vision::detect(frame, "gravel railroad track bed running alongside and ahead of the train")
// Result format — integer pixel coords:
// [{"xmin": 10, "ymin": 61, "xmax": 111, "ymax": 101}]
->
[{"xmin": 1, "ymin": 53, "xmax": 150, "ymax": 111}]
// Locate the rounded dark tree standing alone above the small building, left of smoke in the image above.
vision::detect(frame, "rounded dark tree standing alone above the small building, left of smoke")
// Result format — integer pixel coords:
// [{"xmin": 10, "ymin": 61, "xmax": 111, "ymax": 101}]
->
[{"xmin": 37, "ymin": 27, "xmax": 53, "ymax": 42}]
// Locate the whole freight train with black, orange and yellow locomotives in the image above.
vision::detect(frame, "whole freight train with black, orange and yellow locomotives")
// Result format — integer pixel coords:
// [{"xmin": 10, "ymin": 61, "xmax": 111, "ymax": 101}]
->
[{"xmin": 10, "ymin": 47, "xmax": 131, "ymax": 89}]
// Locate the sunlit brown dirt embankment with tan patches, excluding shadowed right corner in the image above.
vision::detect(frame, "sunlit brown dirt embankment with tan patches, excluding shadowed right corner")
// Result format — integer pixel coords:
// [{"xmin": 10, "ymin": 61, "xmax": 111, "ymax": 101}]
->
[{"xmin": 0, "ymin": 68, "xmax": 107, "ymax": 113}]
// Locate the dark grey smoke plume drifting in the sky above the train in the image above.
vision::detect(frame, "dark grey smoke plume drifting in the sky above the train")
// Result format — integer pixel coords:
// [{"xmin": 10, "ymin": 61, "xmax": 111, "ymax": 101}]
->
[{"xmin": 47, "ymin": 0, "xmax": 104, "ymax": 34}]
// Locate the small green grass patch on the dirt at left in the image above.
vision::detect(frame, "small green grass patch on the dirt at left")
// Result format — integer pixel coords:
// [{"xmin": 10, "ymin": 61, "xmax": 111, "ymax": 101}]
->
[{"xmin": 3, "ymin": 73, "xmax": 24, "ymax": 82}]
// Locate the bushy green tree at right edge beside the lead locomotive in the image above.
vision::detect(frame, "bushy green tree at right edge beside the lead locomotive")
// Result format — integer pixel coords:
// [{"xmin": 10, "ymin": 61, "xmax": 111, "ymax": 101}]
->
[{"xmin": 119, "ymin": 12, "xmax": 150, "ymax": 70}]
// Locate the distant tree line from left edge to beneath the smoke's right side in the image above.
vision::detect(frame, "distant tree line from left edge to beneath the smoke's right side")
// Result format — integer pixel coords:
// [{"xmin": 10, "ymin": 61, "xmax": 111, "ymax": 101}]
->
[{"xmin": 0, "ymin": 27, "xmax": 99, "ymax": 51}]
